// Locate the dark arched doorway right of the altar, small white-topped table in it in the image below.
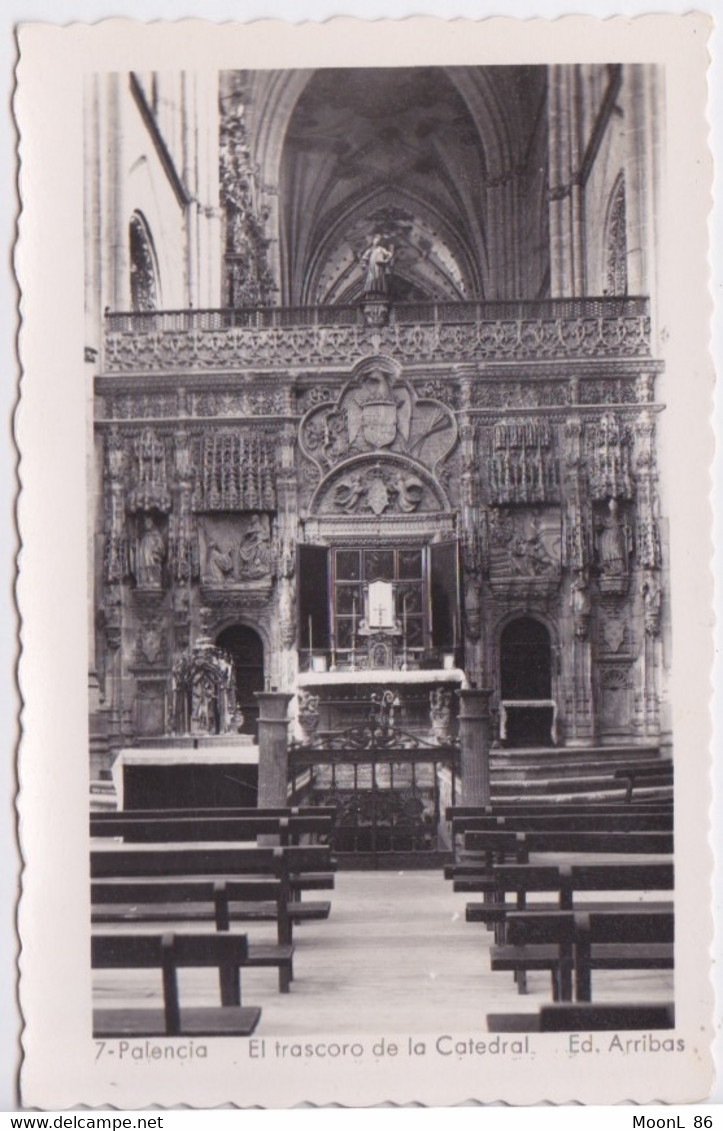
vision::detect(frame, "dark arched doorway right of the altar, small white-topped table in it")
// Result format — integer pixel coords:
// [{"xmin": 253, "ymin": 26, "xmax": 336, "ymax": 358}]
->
[{"xmin": 500, "ymin": 616, "xmax": 554, "ymax": 746}]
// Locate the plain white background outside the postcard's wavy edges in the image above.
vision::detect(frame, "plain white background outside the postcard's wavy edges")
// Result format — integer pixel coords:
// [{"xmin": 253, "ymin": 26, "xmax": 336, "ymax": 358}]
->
[{"xmin": 0, "ymin": 0, "xmax": 723, "ymax": 1112}]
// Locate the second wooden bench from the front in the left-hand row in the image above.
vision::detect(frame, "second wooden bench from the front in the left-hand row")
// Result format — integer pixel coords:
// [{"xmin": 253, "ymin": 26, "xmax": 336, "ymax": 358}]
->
[{"xmin": 91, "ymin": 880, "xmax": 294, "ymax": 993}]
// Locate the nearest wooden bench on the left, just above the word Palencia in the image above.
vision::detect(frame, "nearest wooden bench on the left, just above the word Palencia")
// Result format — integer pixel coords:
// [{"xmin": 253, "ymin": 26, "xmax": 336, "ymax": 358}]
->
[{"xmin": 91, "ymin": 934, "xmax": 261, "ymax": 1038}]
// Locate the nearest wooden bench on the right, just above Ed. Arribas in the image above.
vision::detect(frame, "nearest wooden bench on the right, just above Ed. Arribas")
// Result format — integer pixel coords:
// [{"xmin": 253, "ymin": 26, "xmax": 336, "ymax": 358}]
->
[{"xmin": 487, "ymin": 1002, "xmax": 675, "ymax": 1033}]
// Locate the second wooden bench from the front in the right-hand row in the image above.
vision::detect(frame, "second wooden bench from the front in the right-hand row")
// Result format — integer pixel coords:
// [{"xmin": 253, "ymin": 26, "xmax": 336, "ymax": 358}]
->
[{"xmin": 490, "ymin": 904, "xmax": 674, "ymax": 1001}]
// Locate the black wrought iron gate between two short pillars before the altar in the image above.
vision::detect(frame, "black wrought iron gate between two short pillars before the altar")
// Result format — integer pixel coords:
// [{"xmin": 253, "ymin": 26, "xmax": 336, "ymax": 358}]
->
[{"xmin": 289, "ymin": 692, "xmax": 459, "ymax": 869}]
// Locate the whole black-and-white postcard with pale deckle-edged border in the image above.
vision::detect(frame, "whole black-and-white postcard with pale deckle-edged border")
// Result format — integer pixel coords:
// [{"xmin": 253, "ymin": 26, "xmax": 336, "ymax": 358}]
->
[{"xmin": 14, "ymin": 17, "xmax": 712, "ymax": 1106}]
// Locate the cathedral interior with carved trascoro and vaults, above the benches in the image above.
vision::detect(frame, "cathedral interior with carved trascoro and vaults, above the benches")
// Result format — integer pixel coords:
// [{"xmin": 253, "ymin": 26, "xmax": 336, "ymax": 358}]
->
[{"xmin": 85, "ymin": 64, "xmax": 671, "ymax": 841}]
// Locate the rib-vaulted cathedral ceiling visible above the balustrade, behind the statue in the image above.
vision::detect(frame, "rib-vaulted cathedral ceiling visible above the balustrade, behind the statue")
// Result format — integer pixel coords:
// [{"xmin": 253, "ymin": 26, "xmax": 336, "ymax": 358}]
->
[{"xmin": 279, "ymin": 67, "xmax": 545, "ymax": 303}]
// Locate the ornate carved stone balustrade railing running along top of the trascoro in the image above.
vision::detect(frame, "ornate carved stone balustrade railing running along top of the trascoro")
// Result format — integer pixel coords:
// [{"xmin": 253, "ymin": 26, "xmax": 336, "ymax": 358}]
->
[{"xmin": 103, "ymin": 297, "xmax": 651, "ymax": 374}]
